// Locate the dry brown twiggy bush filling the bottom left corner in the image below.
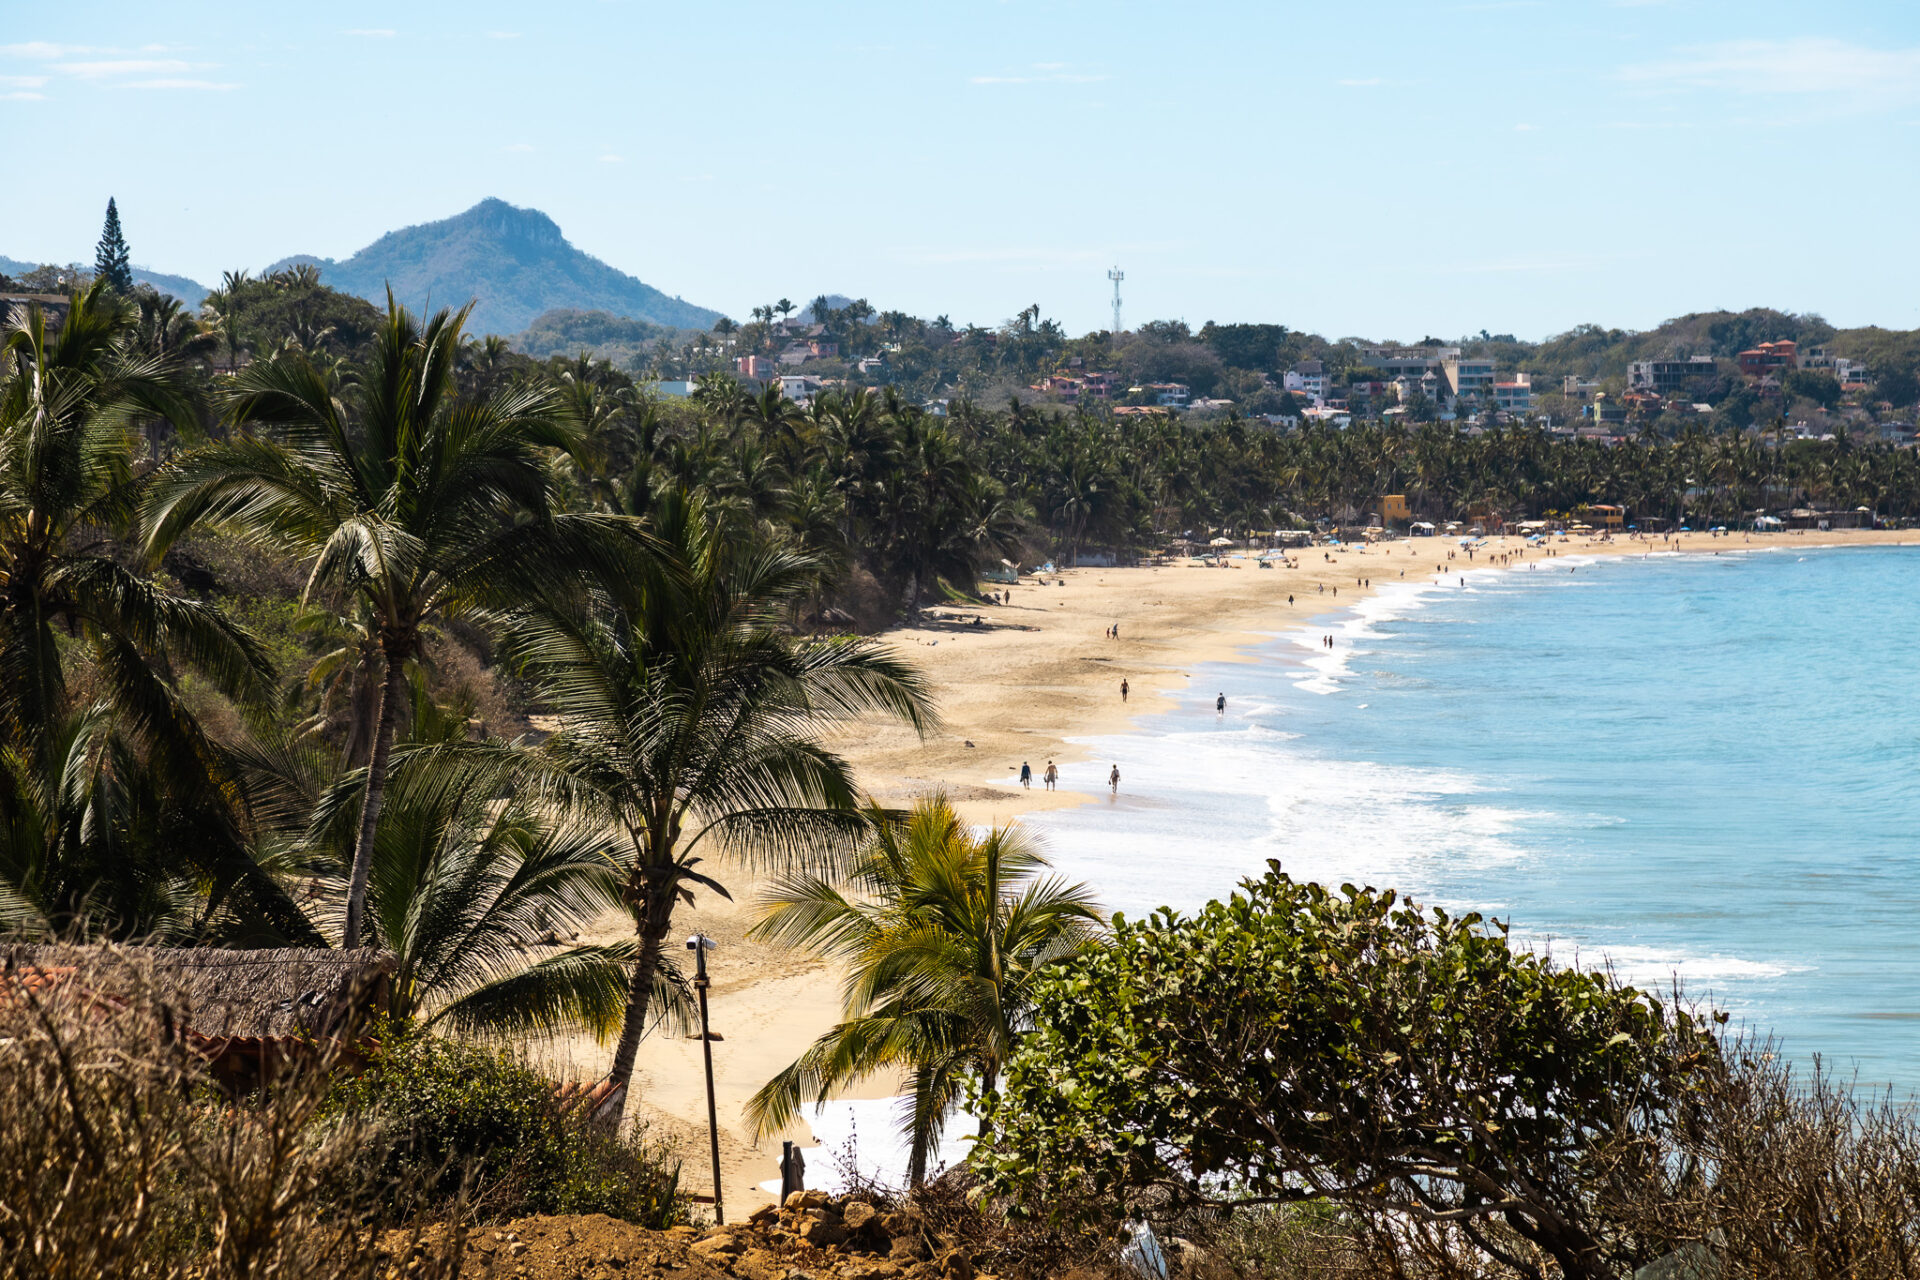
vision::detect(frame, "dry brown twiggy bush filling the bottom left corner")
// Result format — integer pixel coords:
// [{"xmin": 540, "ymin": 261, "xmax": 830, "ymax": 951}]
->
[{"xmin": 0, "ymin": 956, "xmax": 457, "ymax": 1280}]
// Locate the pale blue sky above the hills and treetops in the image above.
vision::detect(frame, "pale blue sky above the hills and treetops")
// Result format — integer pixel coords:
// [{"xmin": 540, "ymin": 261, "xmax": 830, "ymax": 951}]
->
[{"xmin": 0, "ymin": 0, "xmax": 1920, "ymax": 340}]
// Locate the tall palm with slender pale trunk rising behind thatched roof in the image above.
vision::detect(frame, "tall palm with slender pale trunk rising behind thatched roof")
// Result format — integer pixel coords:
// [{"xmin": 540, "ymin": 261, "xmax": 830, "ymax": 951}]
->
[{"xmin": 146, "ymin": 294, "xmax": 618, "ymax": 948}]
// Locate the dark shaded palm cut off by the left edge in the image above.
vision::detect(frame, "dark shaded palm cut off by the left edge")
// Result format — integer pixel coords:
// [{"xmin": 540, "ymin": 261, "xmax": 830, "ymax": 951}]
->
[{"xmin": 0, "ymin": 280, "xmax": 271, "ymax": 741}]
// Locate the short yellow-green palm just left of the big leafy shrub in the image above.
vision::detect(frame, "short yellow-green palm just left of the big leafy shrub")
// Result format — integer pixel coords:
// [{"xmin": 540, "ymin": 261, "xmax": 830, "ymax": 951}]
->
[{"xmin": 747, "ymin": 798, "xmax": 1098, "ymax": 1186}]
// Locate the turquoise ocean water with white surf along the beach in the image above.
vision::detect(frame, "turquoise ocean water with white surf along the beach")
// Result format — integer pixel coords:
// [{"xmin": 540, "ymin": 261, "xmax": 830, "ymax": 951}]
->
[{"xmin": 1027, "ymin": 549, "xmax": 1920, "ymax": 1092}]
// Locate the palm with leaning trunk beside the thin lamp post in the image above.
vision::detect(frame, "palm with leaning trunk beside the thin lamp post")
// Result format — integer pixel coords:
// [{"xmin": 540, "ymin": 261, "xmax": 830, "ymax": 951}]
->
[{"xmin": 513, "ymin": 493, "xmax": 933, "ymax": 1119}]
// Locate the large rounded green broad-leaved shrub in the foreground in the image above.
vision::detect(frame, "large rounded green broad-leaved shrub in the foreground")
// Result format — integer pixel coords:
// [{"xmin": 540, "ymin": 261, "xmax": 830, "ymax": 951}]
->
[{"xmin": 975, "ymin": 864, "xmax": 1718, "ymax": 1276}]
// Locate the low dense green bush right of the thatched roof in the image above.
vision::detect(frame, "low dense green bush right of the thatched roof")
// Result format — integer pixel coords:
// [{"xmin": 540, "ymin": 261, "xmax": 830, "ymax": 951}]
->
[{"xmin": 328, "ymin": 1029, "xmax": 685, "ymax": 1230}]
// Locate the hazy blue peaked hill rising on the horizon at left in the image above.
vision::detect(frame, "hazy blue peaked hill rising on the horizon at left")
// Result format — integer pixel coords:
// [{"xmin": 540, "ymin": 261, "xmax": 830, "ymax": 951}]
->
[{"xmin": 269, "ymin": 200, "xmax": 720, "ymax": 334}]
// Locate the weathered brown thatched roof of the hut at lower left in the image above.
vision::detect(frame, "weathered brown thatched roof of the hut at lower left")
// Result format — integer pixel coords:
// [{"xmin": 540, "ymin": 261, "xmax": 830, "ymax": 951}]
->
[{"xmin": 0, "ymin": 946, "xmax": 394, "ymax": 1040}]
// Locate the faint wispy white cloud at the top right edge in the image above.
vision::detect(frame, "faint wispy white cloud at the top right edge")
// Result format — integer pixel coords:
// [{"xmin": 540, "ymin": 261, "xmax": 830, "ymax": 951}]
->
[{"xmin": 1620, "ymin": 36, "xmax": 1920, "ymax": 107}]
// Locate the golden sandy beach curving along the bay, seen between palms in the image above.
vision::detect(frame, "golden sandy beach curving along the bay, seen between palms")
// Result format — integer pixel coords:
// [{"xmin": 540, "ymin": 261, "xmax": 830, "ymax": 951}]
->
[{"xmin": 538, "ymin": 530, "xmax": 1920, "ymax": 1217}]
